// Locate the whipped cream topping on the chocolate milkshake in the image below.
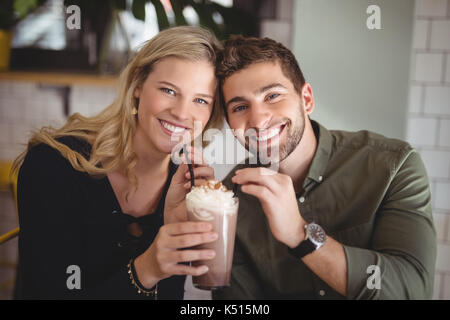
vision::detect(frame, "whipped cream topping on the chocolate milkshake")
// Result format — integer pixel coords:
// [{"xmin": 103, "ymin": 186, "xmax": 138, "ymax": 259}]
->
[{"xmin": 186, "ymin": 180, "xmax": 237, "ymax": 221}]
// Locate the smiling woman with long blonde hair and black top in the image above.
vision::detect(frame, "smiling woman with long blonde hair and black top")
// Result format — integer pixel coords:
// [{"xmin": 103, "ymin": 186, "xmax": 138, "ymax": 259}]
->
[{"xmin": 15, "ymin": 27, "xmax": 222, "ymax": 299}]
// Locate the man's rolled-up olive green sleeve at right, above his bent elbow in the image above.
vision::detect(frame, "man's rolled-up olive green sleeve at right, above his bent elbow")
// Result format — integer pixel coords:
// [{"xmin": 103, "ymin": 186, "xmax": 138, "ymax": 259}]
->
[{"xmin": 344, "ymin": 150, "xmax": 436, "ymax": 299}]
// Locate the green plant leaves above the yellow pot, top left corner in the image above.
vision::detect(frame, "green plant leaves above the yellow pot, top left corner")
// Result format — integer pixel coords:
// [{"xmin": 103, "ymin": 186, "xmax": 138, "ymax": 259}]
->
[{"xmin": 0, "ymin": 0, "xmax": 46, "ymax": 30}]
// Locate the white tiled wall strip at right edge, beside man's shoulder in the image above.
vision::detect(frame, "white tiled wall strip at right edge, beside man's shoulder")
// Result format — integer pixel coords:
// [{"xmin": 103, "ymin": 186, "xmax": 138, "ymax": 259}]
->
[{"xmin": 408, "ymin": 0, "xmax": 450, "ymax": 299}]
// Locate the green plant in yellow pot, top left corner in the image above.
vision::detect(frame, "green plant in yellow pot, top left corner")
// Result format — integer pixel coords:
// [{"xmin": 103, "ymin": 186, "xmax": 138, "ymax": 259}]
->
[{"xmin": 0, "ymin": 0, "xmax": 45, "ymax": 71}]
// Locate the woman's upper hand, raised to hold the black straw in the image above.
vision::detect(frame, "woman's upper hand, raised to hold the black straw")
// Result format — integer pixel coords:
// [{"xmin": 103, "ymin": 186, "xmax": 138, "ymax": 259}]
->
[{"xmin": 164, "ymin": 146, "xmax": 214, "ymax": 224}]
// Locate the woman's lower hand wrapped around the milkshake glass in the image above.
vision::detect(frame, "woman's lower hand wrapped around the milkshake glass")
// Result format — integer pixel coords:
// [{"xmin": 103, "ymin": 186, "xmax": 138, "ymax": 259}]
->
[{"xmin": 134, "ymin": 222, "xmax": 218, "ymax": 288}]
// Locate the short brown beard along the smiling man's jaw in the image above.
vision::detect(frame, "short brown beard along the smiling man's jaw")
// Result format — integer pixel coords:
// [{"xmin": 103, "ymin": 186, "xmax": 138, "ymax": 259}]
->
[{"xmin": 245, "ymin": 105, "xmax": 305, "ymax": 164}]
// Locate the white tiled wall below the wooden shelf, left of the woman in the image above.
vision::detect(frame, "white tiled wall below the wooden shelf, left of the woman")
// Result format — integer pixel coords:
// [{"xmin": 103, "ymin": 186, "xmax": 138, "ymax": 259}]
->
[{"xmin": 0, "ymin": 81, "xmax": 115, "ymax": 160}]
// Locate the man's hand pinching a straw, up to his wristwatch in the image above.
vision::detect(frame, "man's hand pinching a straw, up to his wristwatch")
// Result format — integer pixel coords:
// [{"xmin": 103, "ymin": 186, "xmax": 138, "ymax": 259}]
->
[{"xmin": 232, "ymin": 167, "xmax": 306, "ymax": 248}]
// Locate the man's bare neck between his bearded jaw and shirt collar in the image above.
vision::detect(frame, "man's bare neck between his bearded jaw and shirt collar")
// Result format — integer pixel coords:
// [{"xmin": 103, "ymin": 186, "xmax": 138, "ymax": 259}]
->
[{"xmin": 279, "ymin": 118, "xmax": 318, "ymax": 193}]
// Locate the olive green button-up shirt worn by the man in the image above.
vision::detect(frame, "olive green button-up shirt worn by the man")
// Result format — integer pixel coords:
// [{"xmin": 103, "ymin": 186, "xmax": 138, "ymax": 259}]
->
[{"xmin": 213, "ymin": 121, "xmax": 436, "ymax": 299}]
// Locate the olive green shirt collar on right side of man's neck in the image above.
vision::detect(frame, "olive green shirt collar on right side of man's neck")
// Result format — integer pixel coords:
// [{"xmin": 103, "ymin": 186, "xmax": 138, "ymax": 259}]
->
[{"xmin": 303, "ymin": 120, "xmax": 332, "ymax": 187}]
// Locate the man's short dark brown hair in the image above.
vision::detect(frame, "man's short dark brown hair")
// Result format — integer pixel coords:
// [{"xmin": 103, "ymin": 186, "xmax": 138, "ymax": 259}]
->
[{"xmin": 216, "ymin": 35, "xmax": 305, "ymax": 109}]
